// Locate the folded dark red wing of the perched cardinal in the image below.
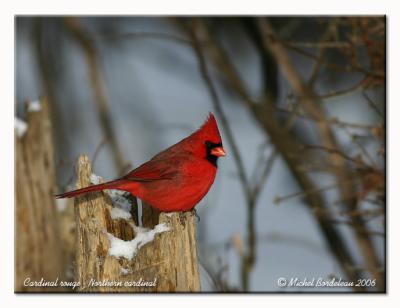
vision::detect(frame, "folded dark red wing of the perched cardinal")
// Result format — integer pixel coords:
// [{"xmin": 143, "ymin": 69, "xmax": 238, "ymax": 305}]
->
[{"xmin": 122, "ymin": 158, "xmax": 178, "ymax": 182}]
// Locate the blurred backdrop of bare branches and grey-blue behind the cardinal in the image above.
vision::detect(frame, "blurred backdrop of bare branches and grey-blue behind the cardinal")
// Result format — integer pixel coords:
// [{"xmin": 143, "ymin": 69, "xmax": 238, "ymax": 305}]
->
[{"xmin": 15, "ymin": 16, "xmax": 386, "ymax": 292}]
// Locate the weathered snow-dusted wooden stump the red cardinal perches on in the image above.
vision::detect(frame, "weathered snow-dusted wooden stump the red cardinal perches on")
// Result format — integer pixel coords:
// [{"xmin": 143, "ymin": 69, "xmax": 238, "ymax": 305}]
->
[{"xmin": 75, "ymin": 155, "xmax": 200, "ymax": 292}]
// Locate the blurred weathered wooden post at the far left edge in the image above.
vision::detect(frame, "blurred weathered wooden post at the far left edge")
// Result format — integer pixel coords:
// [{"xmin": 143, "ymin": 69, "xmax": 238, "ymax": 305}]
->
[{"xmin": 14, "ymin": 99, "xmax": 65, "ymax": 292}]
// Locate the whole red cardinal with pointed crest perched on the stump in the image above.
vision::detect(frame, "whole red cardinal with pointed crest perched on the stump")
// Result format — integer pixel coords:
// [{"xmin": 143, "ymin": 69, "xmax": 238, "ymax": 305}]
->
[{"xmin": 56, "ymin": 113, "xmax": 225, "ymax": 212}]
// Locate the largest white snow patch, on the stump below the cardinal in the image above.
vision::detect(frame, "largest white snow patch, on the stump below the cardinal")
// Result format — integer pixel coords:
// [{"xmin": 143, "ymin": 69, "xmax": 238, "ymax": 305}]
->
[{"xmin": 107, "ymin": 223, "xmax": 170, "ymax": 260}]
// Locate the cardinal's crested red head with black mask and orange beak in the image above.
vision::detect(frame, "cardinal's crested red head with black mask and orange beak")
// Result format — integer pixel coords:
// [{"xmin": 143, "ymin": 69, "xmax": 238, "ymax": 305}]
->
[{"xmin": 189, "ymin": 112, "xmax": 226, "ymax": 166}]
